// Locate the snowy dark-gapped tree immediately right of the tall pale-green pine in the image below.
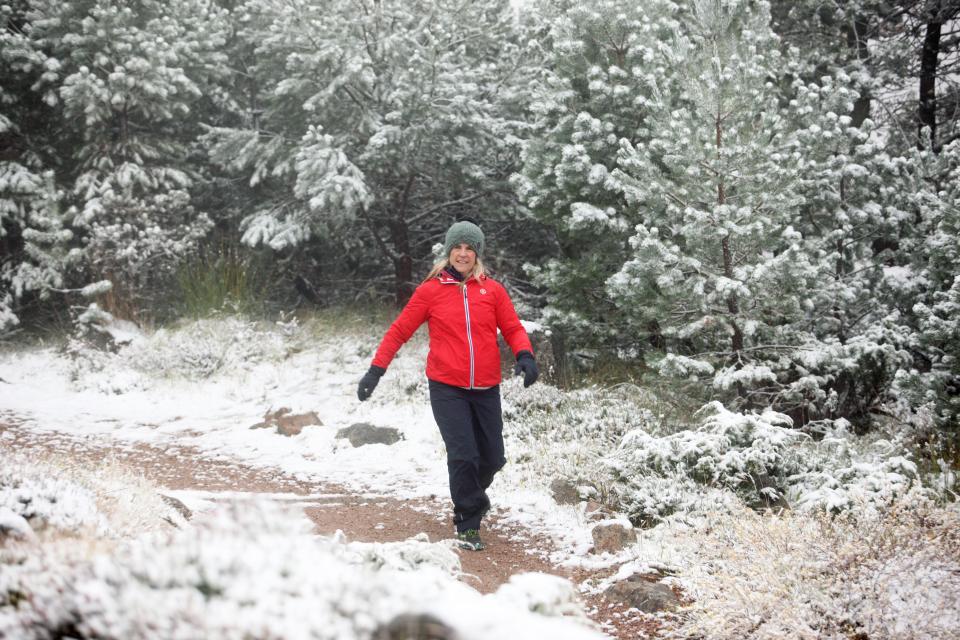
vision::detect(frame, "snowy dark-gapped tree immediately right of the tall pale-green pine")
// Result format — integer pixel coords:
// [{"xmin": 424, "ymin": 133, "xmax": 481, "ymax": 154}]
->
[{"xmin": 772, "ymin": 84, "xmax": 925, "ymax": 427}]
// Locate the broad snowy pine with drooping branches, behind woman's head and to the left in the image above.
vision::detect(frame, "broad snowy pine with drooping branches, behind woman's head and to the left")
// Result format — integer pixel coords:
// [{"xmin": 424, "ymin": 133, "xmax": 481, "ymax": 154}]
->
[{"xmin": 206, "ymin": 0, "xmax": 522, "ymax": 301}]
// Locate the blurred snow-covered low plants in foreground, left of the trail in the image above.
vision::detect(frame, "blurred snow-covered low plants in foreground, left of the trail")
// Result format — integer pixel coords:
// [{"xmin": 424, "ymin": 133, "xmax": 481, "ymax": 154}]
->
[{"xmin": 0, "ymin": 444, "xmax": 599, "ymax": 640}]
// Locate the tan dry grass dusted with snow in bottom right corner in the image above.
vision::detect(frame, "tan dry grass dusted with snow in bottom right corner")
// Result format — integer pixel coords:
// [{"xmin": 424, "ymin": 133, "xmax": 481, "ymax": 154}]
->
[{"xmin": 676, "ymin": 493, "xmax": 960, "ymax": 640}]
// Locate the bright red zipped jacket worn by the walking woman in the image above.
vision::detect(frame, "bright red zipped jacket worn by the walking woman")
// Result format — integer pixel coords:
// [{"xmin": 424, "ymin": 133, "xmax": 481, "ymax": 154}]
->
[{"xmin": 372, "ymin": 272, "xmax": 533, "ymax": 389}]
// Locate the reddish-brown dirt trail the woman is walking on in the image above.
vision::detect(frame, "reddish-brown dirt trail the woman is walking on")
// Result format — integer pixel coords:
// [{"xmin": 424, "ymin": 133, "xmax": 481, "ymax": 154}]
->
[{"xmin": 0, "ymin": 421, "xmax": 656, "ymax": 640}]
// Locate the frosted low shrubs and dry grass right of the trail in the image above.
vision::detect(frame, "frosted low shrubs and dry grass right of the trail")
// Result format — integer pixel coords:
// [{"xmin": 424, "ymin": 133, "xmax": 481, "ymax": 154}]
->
[{"xmin": 505, "ymin": 358, "xmax": 960, "ymax": 640}]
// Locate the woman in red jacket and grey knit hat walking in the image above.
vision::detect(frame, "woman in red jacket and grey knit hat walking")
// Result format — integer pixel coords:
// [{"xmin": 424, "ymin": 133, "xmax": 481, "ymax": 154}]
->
[{"xmin": 357, "ymin": 220, "xmax": 539, "ymax": 551}]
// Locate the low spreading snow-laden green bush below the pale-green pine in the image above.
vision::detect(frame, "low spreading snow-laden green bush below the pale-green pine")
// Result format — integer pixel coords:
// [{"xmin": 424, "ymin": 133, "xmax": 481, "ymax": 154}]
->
[{"xmin": 606, "ymin": 402, "xmax": 933, "ymax": 526}]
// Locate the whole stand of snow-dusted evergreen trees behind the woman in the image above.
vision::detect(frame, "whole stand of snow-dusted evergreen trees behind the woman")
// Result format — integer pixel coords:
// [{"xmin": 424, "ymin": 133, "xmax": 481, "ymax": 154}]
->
[{"xmin": 0, "ymin": 0, "xmax": 960, "ymax": 467}]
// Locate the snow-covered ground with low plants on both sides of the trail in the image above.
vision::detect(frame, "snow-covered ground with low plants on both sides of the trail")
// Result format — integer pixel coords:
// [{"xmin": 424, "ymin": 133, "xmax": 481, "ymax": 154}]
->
[{"xmin": 0, "ymin": 317, "xmax": 960, "ymax": 638}]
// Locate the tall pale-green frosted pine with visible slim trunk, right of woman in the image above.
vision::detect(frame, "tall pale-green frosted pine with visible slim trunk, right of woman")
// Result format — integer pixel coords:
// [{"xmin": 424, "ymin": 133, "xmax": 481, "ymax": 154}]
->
[{"xmin": 608, "ymin": 0, "xmax": 815, "ymax": 404}]
